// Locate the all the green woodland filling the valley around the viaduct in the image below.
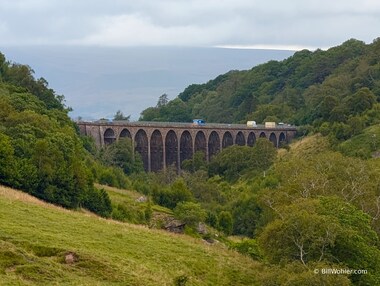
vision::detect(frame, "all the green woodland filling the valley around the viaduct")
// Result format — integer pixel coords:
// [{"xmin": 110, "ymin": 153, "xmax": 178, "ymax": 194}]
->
[{"xmin": 0, "ymin": 40, "xmax": 380, "ymax": 285}]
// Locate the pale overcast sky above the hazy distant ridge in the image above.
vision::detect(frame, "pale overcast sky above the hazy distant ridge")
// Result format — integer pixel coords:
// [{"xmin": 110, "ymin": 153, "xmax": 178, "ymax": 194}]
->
[{"xmin": 0, "ymin": 0, "xmax": 380, "ymax": 49}]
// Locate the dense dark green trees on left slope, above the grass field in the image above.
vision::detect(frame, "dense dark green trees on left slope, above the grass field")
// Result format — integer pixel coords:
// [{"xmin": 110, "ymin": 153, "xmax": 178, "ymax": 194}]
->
[{"xmin": 0, "ymin": 54, "xmax": 112, "ymax": 216}]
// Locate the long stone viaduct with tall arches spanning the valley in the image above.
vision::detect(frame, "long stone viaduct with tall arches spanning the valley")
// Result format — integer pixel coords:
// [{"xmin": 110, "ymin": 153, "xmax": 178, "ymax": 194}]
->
[{"xmin": 77, "ymin": 121, "xmax": 296, "ymax": 172}]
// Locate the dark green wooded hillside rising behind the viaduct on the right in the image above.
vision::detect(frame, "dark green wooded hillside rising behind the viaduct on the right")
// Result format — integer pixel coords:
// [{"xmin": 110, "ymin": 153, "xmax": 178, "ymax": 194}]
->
[{"xmin": 141, "ymin": 39, "xmax": 380, "ymax": 133}]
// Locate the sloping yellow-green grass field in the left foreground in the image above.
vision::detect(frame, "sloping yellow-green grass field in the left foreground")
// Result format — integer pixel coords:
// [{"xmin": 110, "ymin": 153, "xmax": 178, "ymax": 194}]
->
[{"xmin": 0, "ymin": 186, "xmax": 263, "ymax": 285}]
